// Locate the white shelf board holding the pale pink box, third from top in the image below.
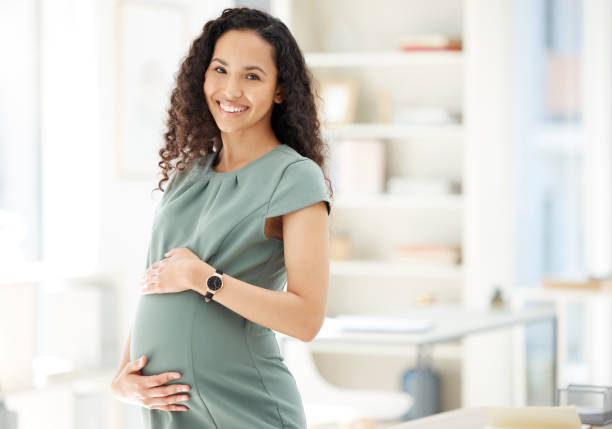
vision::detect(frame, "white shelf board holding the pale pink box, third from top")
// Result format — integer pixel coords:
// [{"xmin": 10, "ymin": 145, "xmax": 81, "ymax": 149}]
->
[{"xmin": 332, "ymin": 194, "xmax": 463, "ymax": 210}]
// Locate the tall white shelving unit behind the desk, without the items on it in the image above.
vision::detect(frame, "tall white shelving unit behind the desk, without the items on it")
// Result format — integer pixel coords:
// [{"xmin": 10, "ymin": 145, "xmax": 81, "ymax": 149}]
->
[{"xmin": 271, "ymin": 0, "xmax": 464, "ymax": 409}]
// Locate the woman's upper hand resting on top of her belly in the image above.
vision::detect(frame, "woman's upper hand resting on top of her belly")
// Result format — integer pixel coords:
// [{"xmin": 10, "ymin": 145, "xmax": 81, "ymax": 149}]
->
[{"xmin": 140, "ymin": 247, "xmax": 206, "ymax": 295}]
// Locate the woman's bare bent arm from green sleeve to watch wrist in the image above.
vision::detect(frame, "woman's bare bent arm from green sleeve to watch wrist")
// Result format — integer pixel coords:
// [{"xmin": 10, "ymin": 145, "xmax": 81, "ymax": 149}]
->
[{"xmin": 193, "ymin": 201, "xmax": 329, "ymax": 341}]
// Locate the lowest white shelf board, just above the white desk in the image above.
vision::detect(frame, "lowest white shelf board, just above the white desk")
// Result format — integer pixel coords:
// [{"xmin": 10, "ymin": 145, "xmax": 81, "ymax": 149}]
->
[{"xmin": 330, "ymin": 259, "xmax": 462, "ymax": 280}]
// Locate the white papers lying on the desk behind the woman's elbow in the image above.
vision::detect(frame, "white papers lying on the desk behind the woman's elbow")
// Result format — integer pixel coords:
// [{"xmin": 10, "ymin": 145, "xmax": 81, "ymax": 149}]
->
[{"xmin": 334, "ymin": 314, "xmax": 433, "ymax": 333}]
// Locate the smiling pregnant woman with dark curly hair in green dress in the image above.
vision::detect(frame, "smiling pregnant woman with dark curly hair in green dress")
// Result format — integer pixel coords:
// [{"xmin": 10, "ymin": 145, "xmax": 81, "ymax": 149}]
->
[{"xmin": 111, "ymin": 8, "xmax": 331, "ymax": 429}]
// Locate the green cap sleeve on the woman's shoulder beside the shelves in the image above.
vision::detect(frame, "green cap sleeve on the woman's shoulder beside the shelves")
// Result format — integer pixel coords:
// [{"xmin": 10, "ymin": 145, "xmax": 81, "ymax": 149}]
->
[{"xmin": 266, "ymin": 158, "xmax": 331, "ymax": 217}]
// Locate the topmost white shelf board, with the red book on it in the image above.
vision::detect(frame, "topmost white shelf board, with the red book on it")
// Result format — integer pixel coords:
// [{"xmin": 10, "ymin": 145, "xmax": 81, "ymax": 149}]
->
[{"xmin": 304, "ymin": 51, "xmax": 463, "ymax": 68}]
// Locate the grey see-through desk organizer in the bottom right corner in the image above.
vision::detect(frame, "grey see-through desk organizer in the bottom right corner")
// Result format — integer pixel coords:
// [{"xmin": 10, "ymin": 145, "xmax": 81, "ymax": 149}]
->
[{"xmin": 556, "ymin": 384, "xmax": 612, "ymax": 425}]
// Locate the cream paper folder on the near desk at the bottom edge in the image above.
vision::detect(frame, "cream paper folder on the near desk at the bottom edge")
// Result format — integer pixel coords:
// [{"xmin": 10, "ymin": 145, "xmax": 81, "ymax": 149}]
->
[{"xmin": 484, "ymin": 405, "xmax": 582, "ymax": 429}]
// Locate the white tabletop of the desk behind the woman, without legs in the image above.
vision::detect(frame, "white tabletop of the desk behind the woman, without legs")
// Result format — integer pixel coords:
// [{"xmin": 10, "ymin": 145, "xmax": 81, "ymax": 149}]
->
[{"xmin": 312, "ymin": 306, "xmax": 556, "ymax": 347}]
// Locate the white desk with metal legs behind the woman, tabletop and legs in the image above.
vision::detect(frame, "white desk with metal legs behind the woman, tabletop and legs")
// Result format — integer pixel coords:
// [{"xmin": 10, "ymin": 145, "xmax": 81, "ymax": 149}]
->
[{"xmin": 280, "ymin": 306, "xmax": 557, "ymax": 420}]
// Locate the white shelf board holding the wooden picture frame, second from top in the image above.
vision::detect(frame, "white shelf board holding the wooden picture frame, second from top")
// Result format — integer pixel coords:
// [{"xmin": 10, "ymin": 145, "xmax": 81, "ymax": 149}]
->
[{"xmin": 322, "ymin": 123, "xmax": 463, "ymax": 139}]
